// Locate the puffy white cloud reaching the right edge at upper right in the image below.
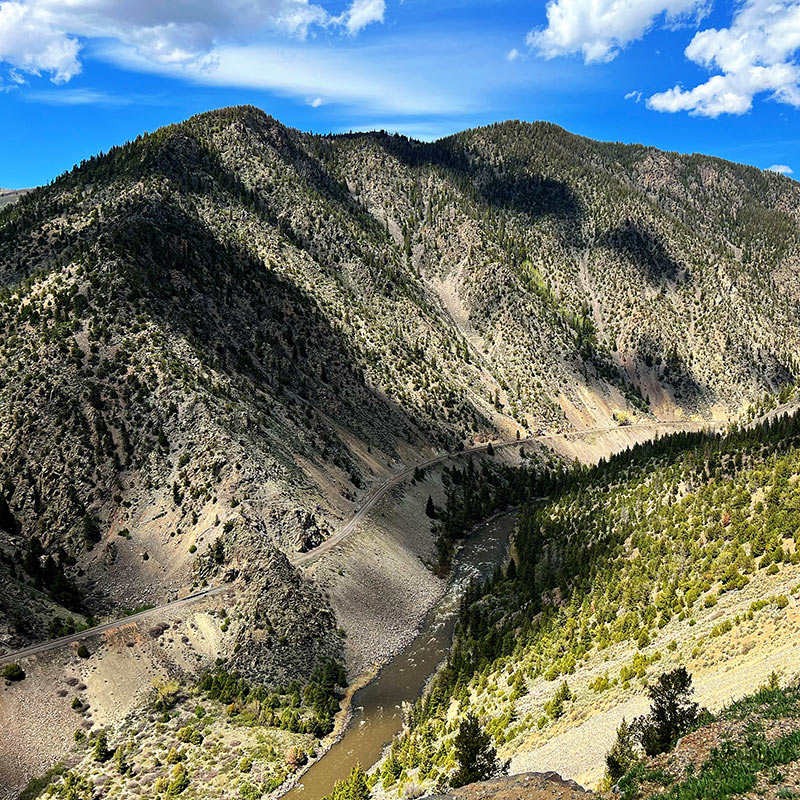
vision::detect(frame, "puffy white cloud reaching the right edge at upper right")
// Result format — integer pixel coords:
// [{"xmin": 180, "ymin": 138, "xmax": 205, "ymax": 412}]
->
[{"xmin": 647, "ymin": 0, "xmax": 800, "ymax": 117}]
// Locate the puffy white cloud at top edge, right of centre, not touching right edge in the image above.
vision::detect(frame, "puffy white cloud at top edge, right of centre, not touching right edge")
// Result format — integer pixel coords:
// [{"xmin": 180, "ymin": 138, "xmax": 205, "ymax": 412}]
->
[{"xmin": 526, "ymin": 0, "xmax": 706, "ymax": 64}]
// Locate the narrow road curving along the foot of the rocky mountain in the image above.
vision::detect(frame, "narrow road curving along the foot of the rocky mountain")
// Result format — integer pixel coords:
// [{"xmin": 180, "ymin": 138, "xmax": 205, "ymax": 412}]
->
[{"xmin": 0, "ymin": 420, "xmax": 713, "ymax": 664}]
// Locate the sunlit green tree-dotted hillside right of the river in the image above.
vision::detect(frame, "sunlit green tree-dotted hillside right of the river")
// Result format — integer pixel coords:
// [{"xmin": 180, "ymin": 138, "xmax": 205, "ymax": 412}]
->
[{"xmin": 381, "ymin": 415, "xmax": 800, "ymax": 792}]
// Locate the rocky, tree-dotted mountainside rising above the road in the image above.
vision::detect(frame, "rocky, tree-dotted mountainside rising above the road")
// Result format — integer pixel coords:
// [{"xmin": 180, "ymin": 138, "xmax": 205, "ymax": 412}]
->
[{"xmin": 0, "ymin": 107, "xmax": 800, "ymax": 669}]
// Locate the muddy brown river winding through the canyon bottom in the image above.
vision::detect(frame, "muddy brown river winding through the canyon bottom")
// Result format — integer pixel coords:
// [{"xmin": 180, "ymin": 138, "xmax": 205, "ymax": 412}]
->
[{"xmin": 283, "ymin": 513, "xmax": 517, "ymax": 800}]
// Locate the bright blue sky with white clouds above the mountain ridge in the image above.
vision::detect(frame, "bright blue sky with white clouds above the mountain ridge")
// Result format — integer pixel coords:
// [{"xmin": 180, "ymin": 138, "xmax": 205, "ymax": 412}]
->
[{"xmin": 0, "ymin": 0, "xmax": 800, "ymax": 188}]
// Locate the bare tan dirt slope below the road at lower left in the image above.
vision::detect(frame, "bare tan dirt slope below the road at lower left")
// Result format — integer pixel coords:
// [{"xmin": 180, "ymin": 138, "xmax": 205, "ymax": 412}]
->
[{"xmin": 0, "ymin": 598, "xmax": 225, "ymax": 800}]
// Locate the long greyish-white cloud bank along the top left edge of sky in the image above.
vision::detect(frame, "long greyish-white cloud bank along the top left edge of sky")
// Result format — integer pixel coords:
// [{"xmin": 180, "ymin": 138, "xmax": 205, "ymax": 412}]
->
[{"xmin": 0, "ymin": 0, "xmax": 385, "ymax": 83}]
